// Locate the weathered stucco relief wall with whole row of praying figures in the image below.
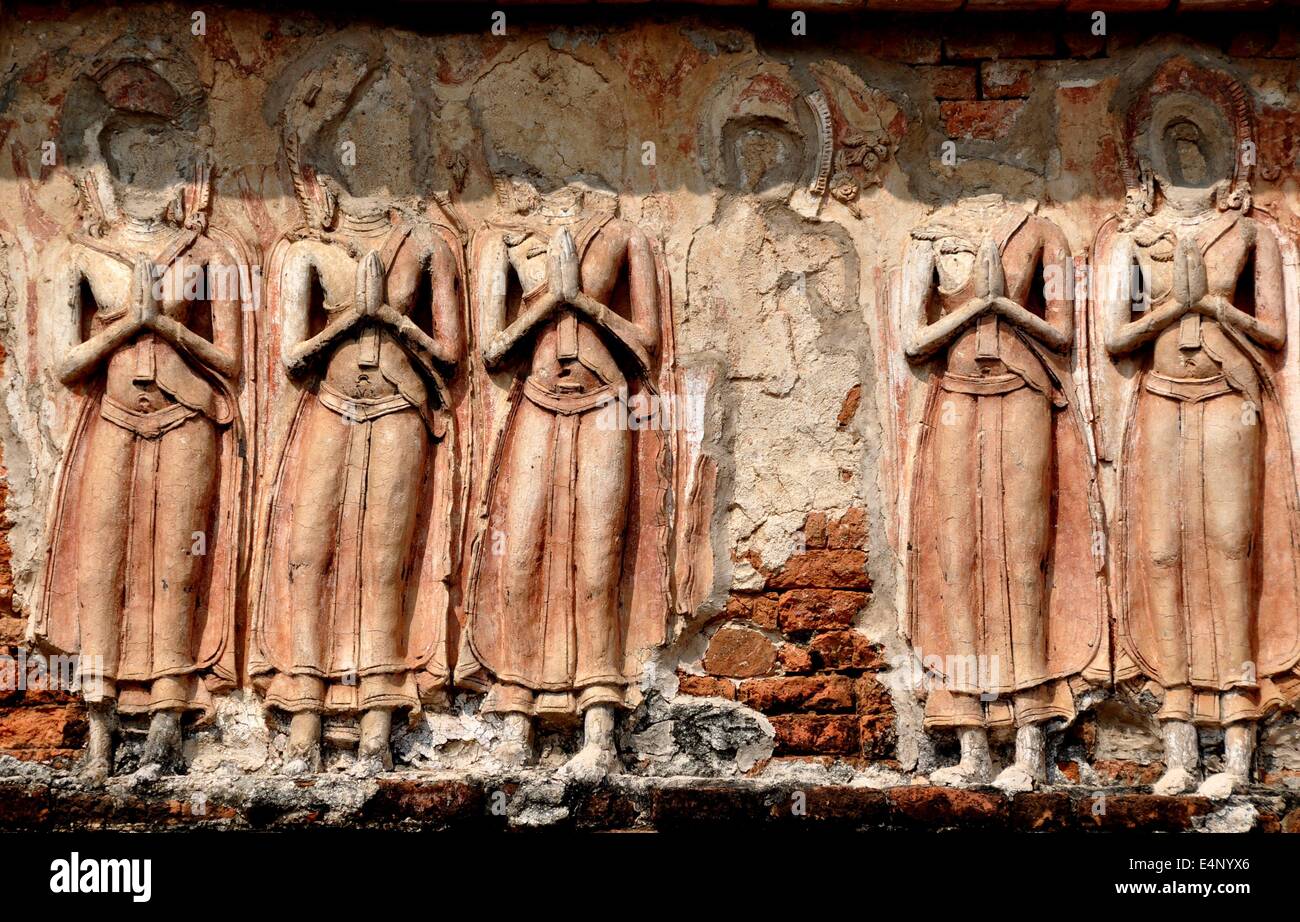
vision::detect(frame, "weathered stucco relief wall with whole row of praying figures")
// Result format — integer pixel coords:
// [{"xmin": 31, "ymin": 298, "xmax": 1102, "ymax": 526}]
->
[{"xmin": 0, "ymin": 14, "xmax": 1300, "ymax": 795}]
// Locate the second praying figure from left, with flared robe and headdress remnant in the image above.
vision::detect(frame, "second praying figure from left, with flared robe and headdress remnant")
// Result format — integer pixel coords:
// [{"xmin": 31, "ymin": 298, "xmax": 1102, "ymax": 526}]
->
[{"xmin": 250, "ymin": 55, "xmax": 464, "ymax": 775}]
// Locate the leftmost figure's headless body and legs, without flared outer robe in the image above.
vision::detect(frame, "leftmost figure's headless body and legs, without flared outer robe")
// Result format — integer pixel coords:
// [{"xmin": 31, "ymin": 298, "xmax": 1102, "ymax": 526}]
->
[{"xmin": 59, "ymin": 221, "xmax": 241, "ymax": 782}]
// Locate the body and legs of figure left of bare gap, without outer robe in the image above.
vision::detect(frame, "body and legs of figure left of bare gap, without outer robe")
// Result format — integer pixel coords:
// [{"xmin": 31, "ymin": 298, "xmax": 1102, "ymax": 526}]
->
[{"xmin": 478, "ymin": 188, "xmax": 659, "ymax": 779}]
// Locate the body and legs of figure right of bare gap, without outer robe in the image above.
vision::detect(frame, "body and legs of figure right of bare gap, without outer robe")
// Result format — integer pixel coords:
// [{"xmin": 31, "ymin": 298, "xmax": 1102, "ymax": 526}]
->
[{"xmin": 907, "ymin": 196, "xmax": 1073, "ymax": 791}]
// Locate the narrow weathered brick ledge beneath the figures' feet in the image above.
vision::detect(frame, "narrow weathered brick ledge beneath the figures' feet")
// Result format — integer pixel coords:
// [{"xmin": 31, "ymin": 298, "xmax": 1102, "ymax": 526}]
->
[{"xmin": 0, "ymin": 766, "xmax": 1300, "ymax": 832}]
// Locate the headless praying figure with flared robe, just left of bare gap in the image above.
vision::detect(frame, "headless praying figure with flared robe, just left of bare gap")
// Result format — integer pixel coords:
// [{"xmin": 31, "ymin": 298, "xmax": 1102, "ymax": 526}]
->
[{"xmin": 456, "ymin": 176, "xmax": 672, "ymax": 779}]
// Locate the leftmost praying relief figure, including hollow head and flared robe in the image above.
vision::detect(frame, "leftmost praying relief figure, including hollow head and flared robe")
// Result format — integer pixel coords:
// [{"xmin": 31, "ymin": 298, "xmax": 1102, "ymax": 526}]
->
[{"xmin": 30, "ymin": 40, "xmax": 252, "ymax": 782}]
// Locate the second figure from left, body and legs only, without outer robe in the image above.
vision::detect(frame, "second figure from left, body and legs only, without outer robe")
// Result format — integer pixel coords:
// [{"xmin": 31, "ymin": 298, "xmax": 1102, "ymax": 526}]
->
[{"xmin": 268, "ymin": 205, "xmax": 463, "ymax": 775}]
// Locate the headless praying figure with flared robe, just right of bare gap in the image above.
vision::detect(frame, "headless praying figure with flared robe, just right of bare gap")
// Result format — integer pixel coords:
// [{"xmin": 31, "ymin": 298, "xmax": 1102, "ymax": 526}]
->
[{"xmin": 902, "ymin": 194, "xmax": 1108, "ymax": 791}]
